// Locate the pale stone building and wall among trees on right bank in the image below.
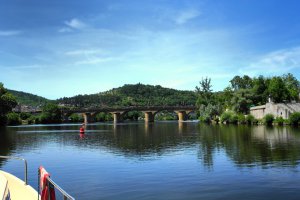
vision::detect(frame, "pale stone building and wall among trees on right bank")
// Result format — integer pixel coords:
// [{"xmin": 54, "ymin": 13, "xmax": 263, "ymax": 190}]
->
[{"xmin": 250, "ymin": 101, "xmax": 300, "ymax": 119}]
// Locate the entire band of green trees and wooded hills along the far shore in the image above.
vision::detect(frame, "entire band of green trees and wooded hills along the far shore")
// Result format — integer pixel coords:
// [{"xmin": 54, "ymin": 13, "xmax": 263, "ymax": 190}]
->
[{"xmin": 0, "ymin": 73, "xmax": 300, "ymax": 125}]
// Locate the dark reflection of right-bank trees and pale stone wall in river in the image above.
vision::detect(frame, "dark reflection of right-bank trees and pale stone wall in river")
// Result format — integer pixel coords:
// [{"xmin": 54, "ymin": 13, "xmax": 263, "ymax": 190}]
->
[{"xmin": 199, "ymin": 125, "xmax": 300, "ymax": 166}]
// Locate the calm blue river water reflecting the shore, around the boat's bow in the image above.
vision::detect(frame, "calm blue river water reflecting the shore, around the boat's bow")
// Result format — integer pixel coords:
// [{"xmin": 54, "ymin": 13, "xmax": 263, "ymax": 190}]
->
[{"xmin": 0, "ymin": 122, "xmax": 300, "ymax": 200}]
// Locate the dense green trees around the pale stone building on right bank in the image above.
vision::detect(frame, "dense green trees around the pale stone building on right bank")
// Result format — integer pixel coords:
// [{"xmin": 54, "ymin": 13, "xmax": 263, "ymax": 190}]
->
[{"xmin": 196, "ymin": 73, "xmax": 300, "ymax": 123}]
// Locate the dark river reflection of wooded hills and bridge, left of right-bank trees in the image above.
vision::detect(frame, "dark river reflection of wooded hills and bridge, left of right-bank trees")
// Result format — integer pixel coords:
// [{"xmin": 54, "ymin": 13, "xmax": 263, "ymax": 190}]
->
[{"xmin": 1, "ymin": 122, "xmax": 197, "ymax": 157}]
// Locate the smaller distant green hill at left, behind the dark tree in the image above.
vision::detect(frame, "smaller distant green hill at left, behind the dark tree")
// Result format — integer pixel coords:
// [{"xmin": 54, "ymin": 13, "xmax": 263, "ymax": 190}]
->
[{"xmin": 8, "ymin": 90, "xmax": 50, "ymax": 107}]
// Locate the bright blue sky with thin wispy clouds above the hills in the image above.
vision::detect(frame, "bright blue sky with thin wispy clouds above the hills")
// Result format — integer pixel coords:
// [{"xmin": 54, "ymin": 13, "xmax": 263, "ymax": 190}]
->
[{"xmin": 0, "ymin": 0, "xmax": 300, "ymax": 99}]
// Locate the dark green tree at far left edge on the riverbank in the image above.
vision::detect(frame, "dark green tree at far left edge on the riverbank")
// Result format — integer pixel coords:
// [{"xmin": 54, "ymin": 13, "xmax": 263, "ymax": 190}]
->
[{"xmin": 0, "ymin": 83, "xmax": 17, "ymax": 125}]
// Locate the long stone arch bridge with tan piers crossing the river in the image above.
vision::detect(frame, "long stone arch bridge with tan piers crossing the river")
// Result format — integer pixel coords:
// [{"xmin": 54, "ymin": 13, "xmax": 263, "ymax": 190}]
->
[{"xmin": 62, "ymin": 106, "xmax": 196, "ymax": 123}]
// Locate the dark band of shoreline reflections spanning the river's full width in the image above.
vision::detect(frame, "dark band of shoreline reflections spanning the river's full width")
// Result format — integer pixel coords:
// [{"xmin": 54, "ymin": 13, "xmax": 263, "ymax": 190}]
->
[{"xmin": 0, "ymin": 122, "xmax": 300, "ymax": 168}]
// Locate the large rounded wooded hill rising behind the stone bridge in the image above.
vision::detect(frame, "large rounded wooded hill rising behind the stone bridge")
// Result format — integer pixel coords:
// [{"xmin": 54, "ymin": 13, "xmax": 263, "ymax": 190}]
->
[{"xmin": 57, "ymin": 83, "xmax": 197, "ymax": 107}]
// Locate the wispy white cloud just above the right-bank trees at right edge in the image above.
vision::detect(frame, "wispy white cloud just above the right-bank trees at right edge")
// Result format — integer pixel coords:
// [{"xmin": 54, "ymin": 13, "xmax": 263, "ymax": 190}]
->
[{"xmin": 239, "ymin": 47, "xmax": 300, "ymax": 76}]
